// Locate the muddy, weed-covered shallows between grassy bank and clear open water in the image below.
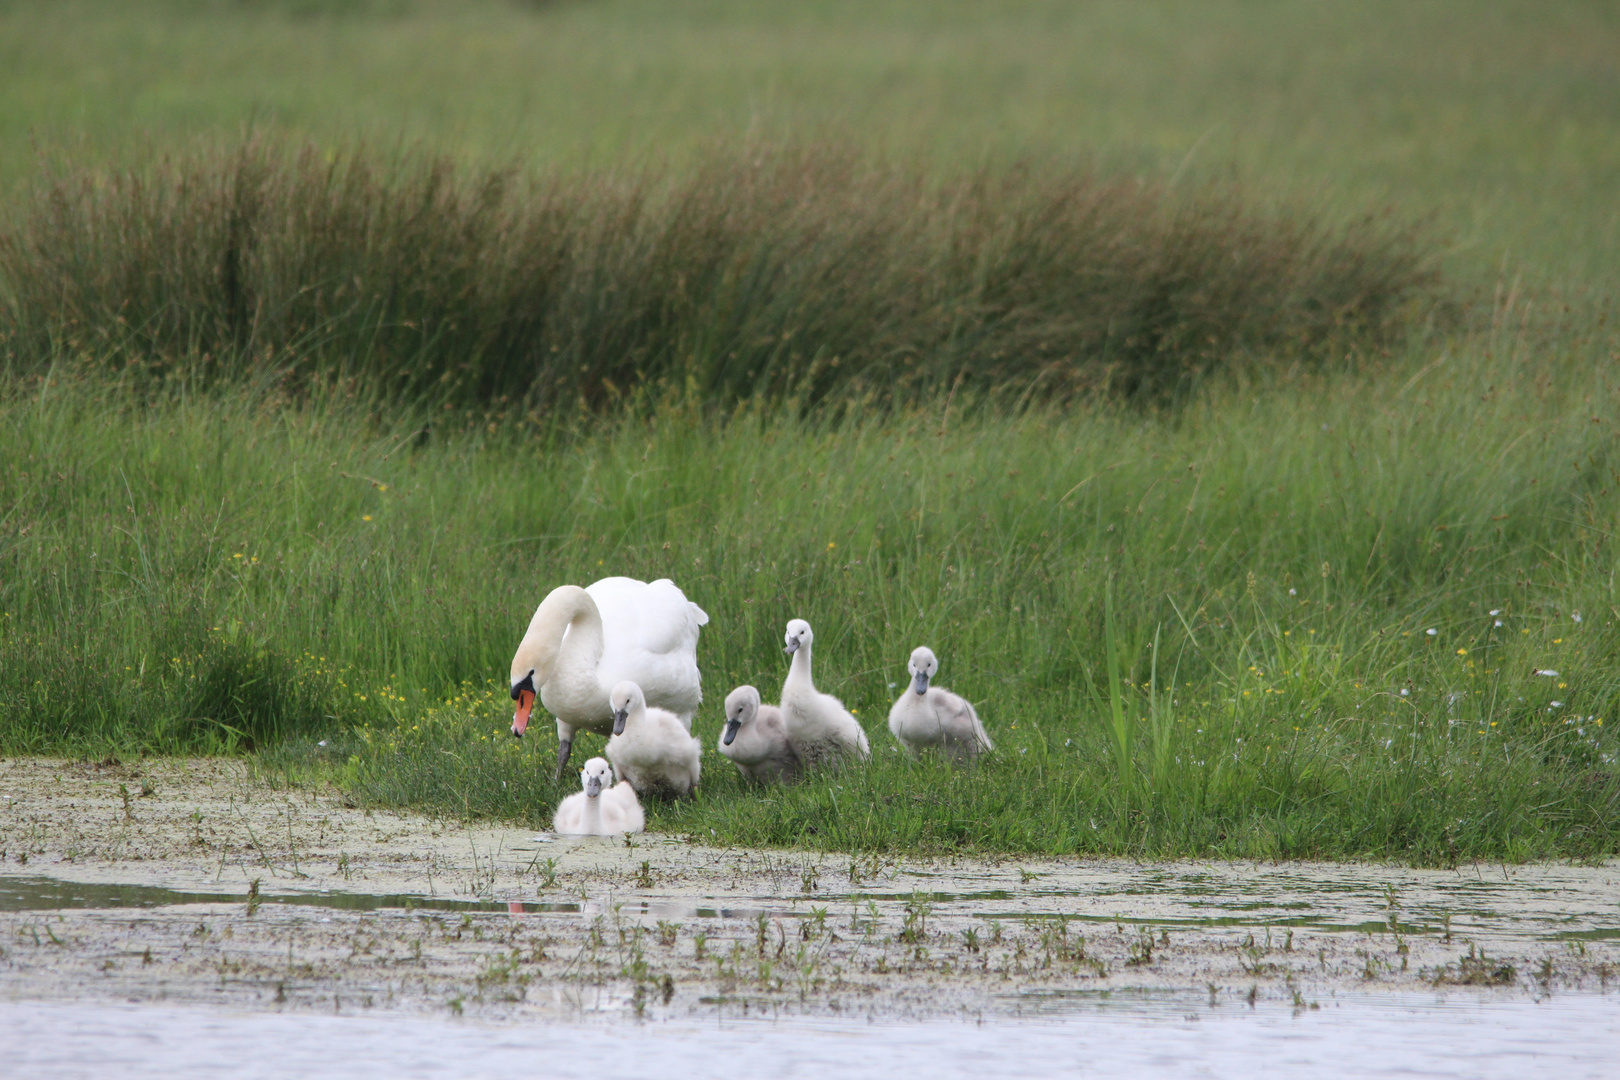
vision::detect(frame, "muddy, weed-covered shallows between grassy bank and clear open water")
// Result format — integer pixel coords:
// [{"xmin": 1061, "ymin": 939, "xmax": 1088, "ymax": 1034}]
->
[{"xmin": 0, "ymin": 758, "xmax": 1620, "ymax": 1022}]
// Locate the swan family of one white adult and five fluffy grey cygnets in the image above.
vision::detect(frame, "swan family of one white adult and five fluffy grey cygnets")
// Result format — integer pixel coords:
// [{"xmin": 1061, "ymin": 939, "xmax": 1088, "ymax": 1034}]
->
[{"xmin": 512, "ymin": 578, "xmax": 993, "ymax": 836}]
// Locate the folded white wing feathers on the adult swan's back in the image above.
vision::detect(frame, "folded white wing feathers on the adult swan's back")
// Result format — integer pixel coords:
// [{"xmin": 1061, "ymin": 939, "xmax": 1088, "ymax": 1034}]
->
[{"xmin": 585, "ymin": 578, "xmax": 708, "ymax": 718}]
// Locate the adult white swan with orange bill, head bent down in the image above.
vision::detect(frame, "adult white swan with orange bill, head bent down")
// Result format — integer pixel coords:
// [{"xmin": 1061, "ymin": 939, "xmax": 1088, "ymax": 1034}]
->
[{"xmin": 512, "ymin": 578, "xmax": 708, "ymax": 780}]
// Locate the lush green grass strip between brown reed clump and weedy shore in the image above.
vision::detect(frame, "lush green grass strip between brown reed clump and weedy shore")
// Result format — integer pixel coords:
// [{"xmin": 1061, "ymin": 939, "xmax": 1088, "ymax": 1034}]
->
[{"xmin": 9, "ymin": 330, "xmax": 1620, "ymax": 860}]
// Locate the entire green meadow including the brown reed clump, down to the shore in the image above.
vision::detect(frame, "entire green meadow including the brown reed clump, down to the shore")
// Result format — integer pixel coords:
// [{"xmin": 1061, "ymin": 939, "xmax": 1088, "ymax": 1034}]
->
[{"xmin": 0, "ymin": 0, "xmax": 1620, "ymax": 865}]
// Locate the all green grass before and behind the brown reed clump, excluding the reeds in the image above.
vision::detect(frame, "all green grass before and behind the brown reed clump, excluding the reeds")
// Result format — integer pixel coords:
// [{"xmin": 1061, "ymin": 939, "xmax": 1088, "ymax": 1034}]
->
[{"xmin": 0, "ymin": 0, "xmax": 1620, "ymax": 863}]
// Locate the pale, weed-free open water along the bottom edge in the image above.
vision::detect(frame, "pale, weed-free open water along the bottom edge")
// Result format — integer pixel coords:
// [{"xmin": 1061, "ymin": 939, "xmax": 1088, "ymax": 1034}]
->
[{"xmin": 0, "ymin": 994, "xmax": 1620, "ymax": 1080}]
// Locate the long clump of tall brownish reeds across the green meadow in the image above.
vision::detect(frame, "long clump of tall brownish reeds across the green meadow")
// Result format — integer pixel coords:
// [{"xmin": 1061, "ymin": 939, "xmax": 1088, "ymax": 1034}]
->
[{"xmin": 0, "ymin": 138, "xmax": 1437, "ymax": 404}]
